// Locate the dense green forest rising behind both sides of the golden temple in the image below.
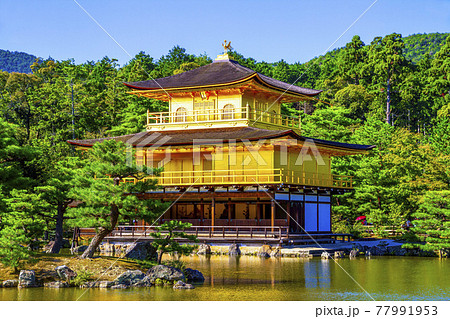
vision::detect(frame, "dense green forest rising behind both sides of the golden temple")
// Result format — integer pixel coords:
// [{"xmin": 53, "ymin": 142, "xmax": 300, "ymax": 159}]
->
[{"xmin": 0, "ymin": 33, "xmax": 450, "ymax": 262}]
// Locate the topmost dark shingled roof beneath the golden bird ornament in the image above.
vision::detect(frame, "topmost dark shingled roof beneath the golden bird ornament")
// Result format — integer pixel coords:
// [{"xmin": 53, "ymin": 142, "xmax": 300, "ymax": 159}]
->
[{"xmin": 124, "ymin": 60, "xmax": 322, "ymax": 96}]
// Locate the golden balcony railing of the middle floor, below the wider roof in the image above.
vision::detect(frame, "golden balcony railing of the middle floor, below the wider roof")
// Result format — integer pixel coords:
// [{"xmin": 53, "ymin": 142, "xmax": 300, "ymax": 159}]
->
[{"xmin": 121, "ymin": 169, "xmax": 353, "ymax": 189}]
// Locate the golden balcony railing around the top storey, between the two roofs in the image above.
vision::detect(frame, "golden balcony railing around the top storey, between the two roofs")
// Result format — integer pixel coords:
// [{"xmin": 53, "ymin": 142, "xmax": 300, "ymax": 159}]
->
[{"xmin": 147, "ymin": 107, "xmax": 301, "ymax": 128}]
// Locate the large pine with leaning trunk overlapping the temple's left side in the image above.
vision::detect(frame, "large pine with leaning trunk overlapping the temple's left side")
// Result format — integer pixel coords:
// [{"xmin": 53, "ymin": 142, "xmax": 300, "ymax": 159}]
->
[{"xmin": 68, "ymin": 140, "xmax": 167, "ymax": 258}]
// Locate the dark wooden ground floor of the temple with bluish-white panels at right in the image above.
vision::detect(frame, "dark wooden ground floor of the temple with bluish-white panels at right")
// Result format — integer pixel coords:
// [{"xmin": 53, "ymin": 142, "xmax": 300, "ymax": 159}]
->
[{"xmin": 137, "ymin": 192, "xmax": 332, "ymax": 233}]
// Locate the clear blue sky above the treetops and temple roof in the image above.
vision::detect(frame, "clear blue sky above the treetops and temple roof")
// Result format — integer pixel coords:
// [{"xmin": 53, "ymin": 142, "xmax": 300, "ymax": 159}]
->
[{"xmin": 0, "ymin": 0, "xmax": 450, "ymax": 64}]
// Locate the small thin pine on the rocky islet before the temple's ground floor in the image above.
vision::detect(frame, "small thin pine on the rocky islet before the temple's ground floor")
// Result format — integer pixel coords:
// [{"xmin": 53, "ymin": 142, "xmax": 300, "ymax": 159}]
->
[{"xmin": 150, "ymin": 220, "xmax": 198, "ymax": 264}]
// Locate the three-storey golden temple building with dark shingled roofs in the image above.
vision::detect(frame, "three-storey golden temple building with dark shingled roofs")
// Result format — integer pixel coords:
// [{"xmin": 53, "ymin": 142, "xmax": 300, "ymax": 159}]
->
[{"xmin": 69, "ymin": 43, "xmax": 374, "ymax": 245}]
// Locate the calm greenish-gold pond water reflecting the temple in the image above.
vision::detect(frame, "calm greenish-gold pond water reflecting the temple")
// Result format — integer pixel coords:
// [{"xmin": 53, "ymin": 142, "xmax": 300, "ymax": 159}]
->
[{"xmin": 0, "ymin": 256, "xmax": 450, "ymax": 301}]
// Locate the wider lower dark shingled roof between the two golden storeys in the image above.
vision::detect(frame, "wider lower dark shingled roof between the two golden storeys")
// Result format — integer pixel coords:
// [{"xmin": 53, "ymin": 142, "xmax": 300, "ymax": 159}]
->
[{"xmin": 67, "ymin": 127, "xmax": 375, "ymax": 151}]
